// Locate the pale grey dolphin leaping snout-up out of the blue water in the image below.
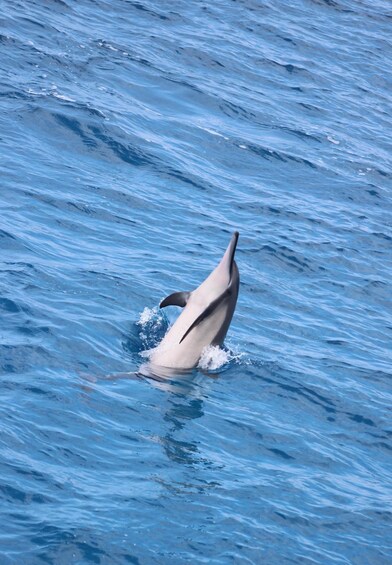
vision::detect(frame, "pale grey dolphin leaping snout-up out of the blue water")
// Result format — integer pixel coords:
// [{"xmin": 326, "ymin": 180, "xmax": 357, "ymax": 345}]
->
[{"xmin": 149, "ymin": 231, "xmax": 240, "ymax": 370}]
